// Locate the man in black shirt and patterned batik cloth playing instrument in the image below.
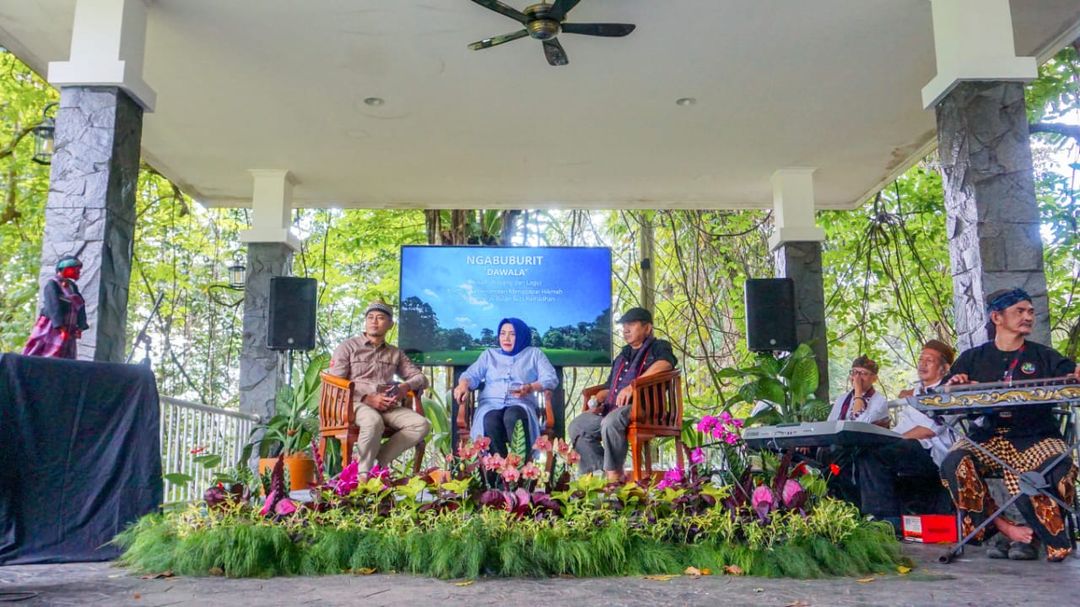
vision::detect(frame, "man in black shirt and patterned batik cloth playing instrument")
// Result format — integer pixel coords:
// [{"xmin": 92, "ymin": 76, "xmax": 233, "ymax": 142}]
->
[{"xmin": 941, "ymin": 288, "xmax": 1077, "ymax": 561}]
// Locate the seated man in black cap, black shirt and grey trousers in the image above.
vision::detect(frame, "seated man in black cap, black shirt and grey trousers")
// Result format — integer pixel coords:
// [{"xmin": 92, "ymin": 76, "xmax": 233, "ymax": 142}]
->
[{"xmin": 568, "ymin": 308, "xmax": 678, "ymax": 481}]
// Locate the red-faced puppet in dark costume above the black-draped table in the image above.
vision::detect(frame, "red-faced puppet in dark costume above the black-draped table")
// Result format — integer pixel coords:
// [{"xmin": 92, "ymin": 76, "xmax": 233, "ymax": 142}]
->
[{"xmin": 23, "ymin": 257, "xmax": 90, "ymax": 359}]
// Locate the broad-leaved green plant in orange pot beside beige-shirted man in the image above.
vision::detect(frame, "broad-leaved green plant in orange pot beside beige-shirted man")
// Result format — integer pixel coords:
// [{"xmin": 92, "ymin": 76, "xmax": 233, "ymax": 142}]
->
[{"xmin": 259, "ymin": 354, "xmax": 329, "ymax": 490}]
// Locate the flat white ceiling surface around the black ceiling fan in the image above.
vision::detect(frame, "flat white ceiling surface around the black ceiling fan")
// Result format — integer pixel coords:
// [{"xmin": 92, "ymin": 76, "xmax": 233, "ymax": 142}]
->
[{"xmin": 0, "ymin": 0, "xmax": 1080, "ymax": 208}]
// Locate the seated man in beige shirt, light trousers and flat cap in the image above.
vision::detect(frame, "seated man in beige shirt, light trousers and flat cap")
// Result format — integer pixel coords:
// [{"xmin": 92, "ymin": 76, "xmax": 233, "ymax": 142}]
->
[{"xmin": 329, "ymin": 301, "xmax": 431, "ymax": 477}]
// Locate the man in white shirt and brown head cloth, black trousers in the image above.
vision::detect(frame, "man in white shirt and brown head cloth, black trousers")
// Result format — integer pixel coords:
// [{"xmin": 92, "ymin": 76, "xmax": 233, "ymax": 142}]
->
[{"xmin": 856, "ymin": 339, "xmax": 956, "ymax": 531}]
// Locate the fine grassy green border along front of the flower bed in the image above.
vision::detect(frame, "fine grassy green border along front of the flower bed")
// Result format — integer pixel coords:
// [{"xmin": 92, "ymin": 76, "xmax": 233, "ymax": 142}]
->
[{"xmin": 116, "ymin": 500, "xmax": 901, "ymax": 579}]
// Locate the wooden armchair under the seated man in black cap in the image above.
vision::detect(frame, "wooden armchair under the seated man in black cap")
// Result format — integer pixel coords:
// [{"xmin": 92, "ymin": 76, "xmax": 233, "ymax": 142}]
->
[{"xmin": 581, "ymin": 369, "xmax": 685, "ymax": 481}]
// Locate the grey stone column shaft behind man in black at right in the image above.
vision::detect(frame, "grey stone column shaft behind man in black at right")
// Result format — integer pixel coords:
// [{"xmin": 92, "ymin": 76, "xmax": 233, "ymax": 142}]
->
[{"xmin": 936, "ymin": 82, "xmax": 1050, "ymax": 350}]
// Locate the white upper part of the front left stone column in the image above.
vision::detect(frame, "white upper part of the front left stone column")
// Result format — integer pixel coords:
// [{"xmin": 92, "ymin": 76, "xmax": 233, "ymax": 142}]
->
[{"xmin": 49, "ymin": 0, "xmax": 157, "ymax": 111}]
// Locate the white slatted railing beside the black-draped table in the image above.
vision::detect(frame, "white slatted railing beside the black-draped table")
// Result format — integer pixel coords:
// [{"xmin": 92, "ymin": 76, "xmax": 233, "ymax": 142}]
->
[{"xmin": 161, "ymin": 396, "xmax": 259, "ymax": 504}]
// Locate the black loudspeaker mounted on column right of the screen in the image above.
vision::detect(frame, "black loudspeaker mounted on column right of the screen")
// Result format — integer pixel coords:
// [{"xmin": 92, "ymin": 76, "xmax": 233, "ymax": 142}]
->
[{"xmin": 746, "ymin": 279, "xmax": 798, "ymax": 352}]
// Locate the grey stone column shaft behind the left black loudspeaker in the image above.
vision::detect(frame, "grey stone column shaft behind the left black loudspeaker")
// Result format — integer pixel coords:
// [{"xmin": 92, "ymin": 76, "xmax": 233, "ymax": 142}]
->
[{"xmin": 240, "ymin": 242, "xmax": 293, "ymax": 419}]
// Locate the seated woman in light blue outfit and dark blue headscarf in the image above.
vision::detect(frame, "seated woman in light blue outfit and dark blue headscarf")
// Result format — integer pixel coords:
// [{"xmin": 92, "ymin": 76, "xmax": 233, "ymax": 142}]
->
[{"xmin": 454, "ymin": 319, "xmax": 558, "ymax": 457}]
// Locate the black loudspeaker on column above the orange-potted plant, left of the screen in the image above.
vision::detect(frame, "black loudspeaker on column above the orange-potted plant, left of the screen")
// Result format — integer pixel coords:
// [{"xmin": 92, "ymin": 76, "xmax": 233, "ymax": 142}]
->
[{"xmin": 267, "ymin": 276, "xmax": 319, "ymax": 350}]
